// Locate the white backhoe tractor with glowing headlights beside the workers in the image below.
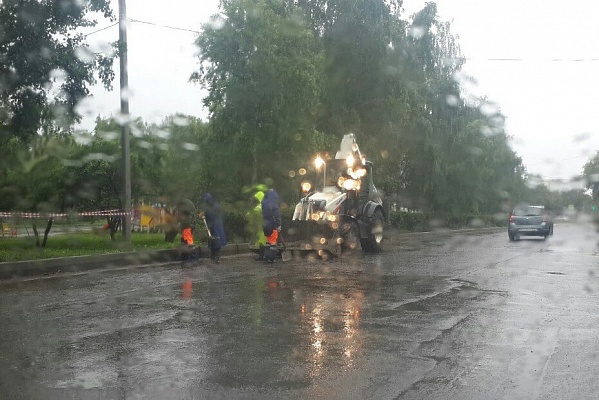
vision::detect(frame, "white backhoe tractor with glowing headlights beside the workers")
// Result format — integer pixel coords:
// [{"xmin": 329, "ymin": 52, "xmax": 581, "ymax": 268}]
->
[{"xmin": 281, "ymin": 134, "xmax": 387, "ymax": 258}]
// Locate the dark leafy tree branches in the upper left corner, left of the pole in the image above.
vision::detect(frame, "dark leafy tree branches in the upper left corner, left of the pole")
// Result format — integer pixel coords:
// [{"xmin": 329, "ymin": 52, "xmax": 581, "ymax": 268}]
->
[{"xmin": 0, "ymin": 0, "xmax": 113, "ymax": 142}]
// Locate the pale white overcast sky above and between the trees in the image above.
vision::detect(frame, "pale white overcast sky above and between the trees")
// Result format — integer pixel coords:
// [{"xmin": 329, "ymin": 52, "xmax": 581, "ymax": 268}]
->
[{"xmin": 81, "ymin": 0, "xmax": 599, "ymax": 179}]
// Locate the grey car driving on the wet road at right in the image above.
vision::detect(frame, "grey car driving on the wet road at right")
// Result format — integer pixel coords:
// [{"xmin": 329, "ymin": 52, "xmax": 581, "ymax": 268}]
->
[{"xmin": 507, "ymin": 205, "xmax": 553, "ymax": 241}]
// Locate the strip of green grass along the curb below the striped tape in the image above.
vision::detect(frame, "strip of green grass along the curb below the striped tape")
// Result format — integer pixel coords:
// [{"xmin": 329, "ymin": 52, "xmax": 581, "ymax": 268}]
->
[{"xmin": 0, "ymin": 229, "xmax": 179, "ymax": 262}]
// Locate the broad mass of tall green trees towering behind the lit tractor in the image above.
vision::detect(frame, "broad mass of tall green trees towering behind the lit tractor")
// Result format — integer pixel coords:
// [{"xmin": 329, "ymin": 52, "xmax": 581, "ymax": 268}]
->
[{"xmin": 195, "ymin": 0, "xmax": 525, "ymax": 215}]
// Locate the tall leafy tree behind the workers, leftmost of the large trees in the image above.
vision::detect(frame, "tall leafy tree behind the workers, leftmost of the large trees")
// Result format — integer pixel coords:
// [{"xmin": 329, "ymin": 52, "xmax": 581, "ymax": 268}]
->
[{"xmin": 192, "ymin": 0, "xmax": 322, "ymax": 195}]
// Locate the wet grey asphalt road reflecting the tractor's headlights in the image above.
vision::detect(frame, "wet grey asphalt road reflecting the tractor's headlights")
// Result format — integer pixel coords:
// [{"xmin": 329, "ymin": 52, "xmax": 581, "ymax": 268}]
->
[{"xmin": 0, "ymin": 220, "xmax": 599, "ymax": 399}]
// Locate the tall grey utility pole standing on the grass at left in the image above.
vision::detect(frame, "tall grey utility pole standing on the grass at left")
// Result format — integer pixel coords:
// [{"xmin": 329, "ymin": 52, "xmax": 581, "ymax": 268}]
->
[{"xmin": 119, "ymin": 0, "xmax": 131, "ymax": 245}]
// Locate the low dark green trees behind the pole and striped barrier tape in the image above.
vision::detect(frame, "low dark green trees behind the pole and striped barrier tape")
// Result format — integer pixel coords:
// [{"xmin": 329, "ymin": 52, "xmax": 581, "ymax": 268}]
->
[{"xmin": 0, "ymin": 115, "xmax": 218, "ymax": 217}]
